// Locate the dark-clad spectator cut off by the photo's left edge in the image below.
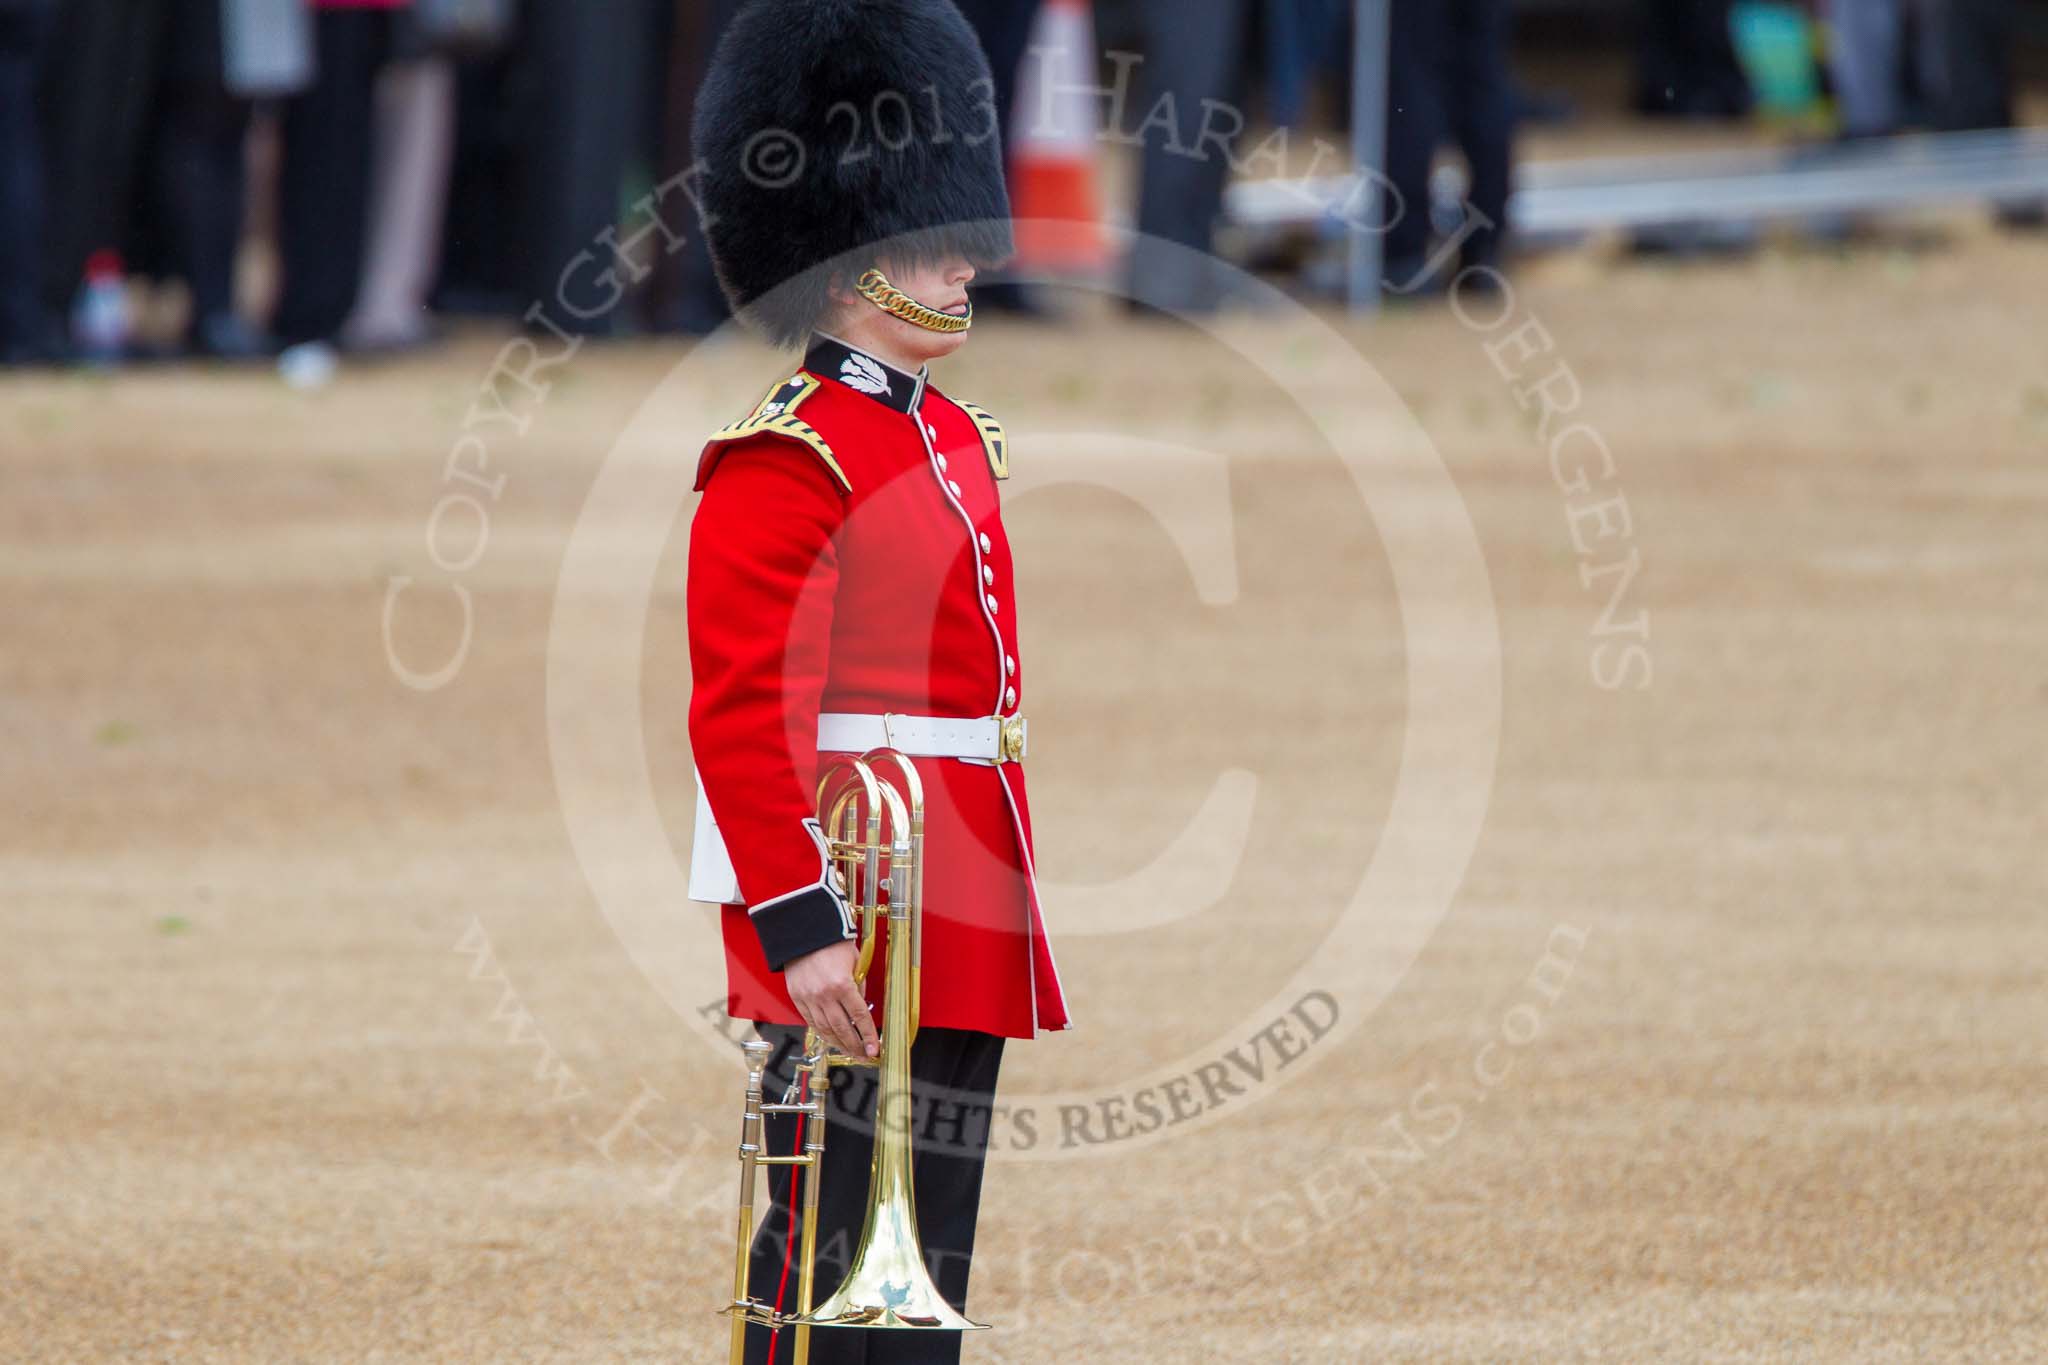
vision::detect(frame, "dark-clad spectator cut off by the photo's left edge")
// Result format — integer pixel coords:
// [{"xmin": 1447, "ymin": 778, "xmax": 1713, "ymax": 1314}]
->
[{"xmin": 0, "ymin": 0, "xmax": 53, "ymax": 364}]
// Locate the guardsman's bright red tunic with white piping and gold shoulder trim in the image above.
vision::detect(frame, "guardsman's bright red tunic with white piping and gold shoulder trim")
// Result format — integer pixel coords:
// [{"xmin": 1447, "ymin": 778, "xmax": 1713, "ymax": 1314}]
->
[{"xmin": 688, "ymin": 338, "xmax": 1067, "ymax": 1038}]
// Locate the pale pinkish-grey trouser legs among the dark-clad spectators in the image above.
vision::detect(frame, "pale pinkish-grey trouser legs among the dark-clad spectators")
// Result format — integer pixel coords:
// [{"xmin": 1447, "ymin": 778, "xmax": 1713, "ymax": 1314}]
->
[{"xmin": 342, "ymin": 57, "xmax": 455, "ymax": 352}]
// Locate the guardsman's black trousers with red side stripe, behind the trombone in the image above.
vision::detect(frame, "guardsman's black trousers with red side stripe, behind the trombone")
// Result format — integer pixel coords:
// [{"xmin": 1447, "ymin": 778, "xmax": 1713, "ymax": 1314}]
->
[{"xmin": 748, "ymin": 1023, "xmax": 1004, "ymax": 1365}]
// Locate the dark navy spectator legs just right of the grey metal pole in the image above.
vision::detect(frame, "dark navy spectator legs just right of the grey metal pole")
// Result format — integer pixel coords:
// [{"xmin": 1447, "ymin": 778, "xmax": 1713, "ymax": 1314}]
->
[{"xmin": 1384, "ymin": 0, "xmax": 1516, "ymax": 293}]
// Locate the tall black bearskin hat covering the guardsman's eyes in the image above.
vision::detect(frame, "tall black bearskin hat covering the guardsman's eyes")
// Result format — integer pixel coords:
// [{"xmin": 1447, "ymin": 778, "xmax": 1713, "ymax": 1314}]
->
[{"xmin": 694, "ymin": 0, "xmax": 1012, "ymax": 346}]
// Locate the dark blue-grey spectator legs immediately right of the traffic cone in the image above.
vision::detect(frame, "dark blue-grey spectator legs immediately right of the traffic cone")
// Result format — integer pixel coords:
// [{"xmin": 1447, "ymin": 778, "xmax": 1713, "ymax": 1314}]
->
[{"xmin": 1122, "ymin": 0, "xmax": 1249, "ymax": 313}]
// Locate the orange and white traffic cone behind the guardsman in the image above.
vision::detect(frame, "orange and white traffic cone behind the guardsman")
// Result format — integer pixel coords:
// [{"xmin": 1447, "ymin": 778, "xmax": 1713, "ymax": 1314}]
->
[{"xmin": 1010, "ymin": 0, "xmax": 1108, "ymax": 274}]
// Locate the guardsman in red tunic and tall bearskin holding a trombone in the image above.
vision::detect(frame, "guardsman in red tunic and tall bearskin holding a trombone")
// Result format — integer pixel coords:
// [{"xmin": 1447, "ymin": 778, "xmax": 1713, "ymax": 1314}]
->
[{"xmin": 688, "ymin": 0, "xmax": 1067, "ymax": 1363}]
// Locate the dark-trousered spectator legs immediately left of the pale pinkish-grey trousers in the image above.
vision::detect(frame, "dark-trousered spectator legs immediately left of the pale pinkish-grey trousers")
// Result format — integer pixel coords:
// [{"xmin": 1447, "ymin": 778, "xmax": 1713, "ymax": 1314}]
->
[{"xmin": 270, "ymin": 8, "xmax": 391, "ymax": 346}]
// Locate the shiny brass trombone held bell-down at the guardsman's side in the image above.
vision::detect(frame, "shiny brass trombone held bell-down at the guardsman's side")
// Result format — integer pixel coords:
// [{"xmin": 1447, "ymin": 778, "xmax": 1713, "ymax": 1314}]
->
[{"xmin": 719, "ymin": 749, "xmax": 987, "ymax": 1365}]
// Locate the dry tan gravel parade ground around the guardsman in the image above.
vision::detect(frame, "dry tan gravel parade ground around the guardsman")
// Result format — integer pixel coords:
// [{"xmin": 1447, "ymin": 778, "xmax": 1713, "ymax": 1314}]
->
[{"xmin": 0, "ymin": 225, "xmax": 2048, "ymax": 1365}]
